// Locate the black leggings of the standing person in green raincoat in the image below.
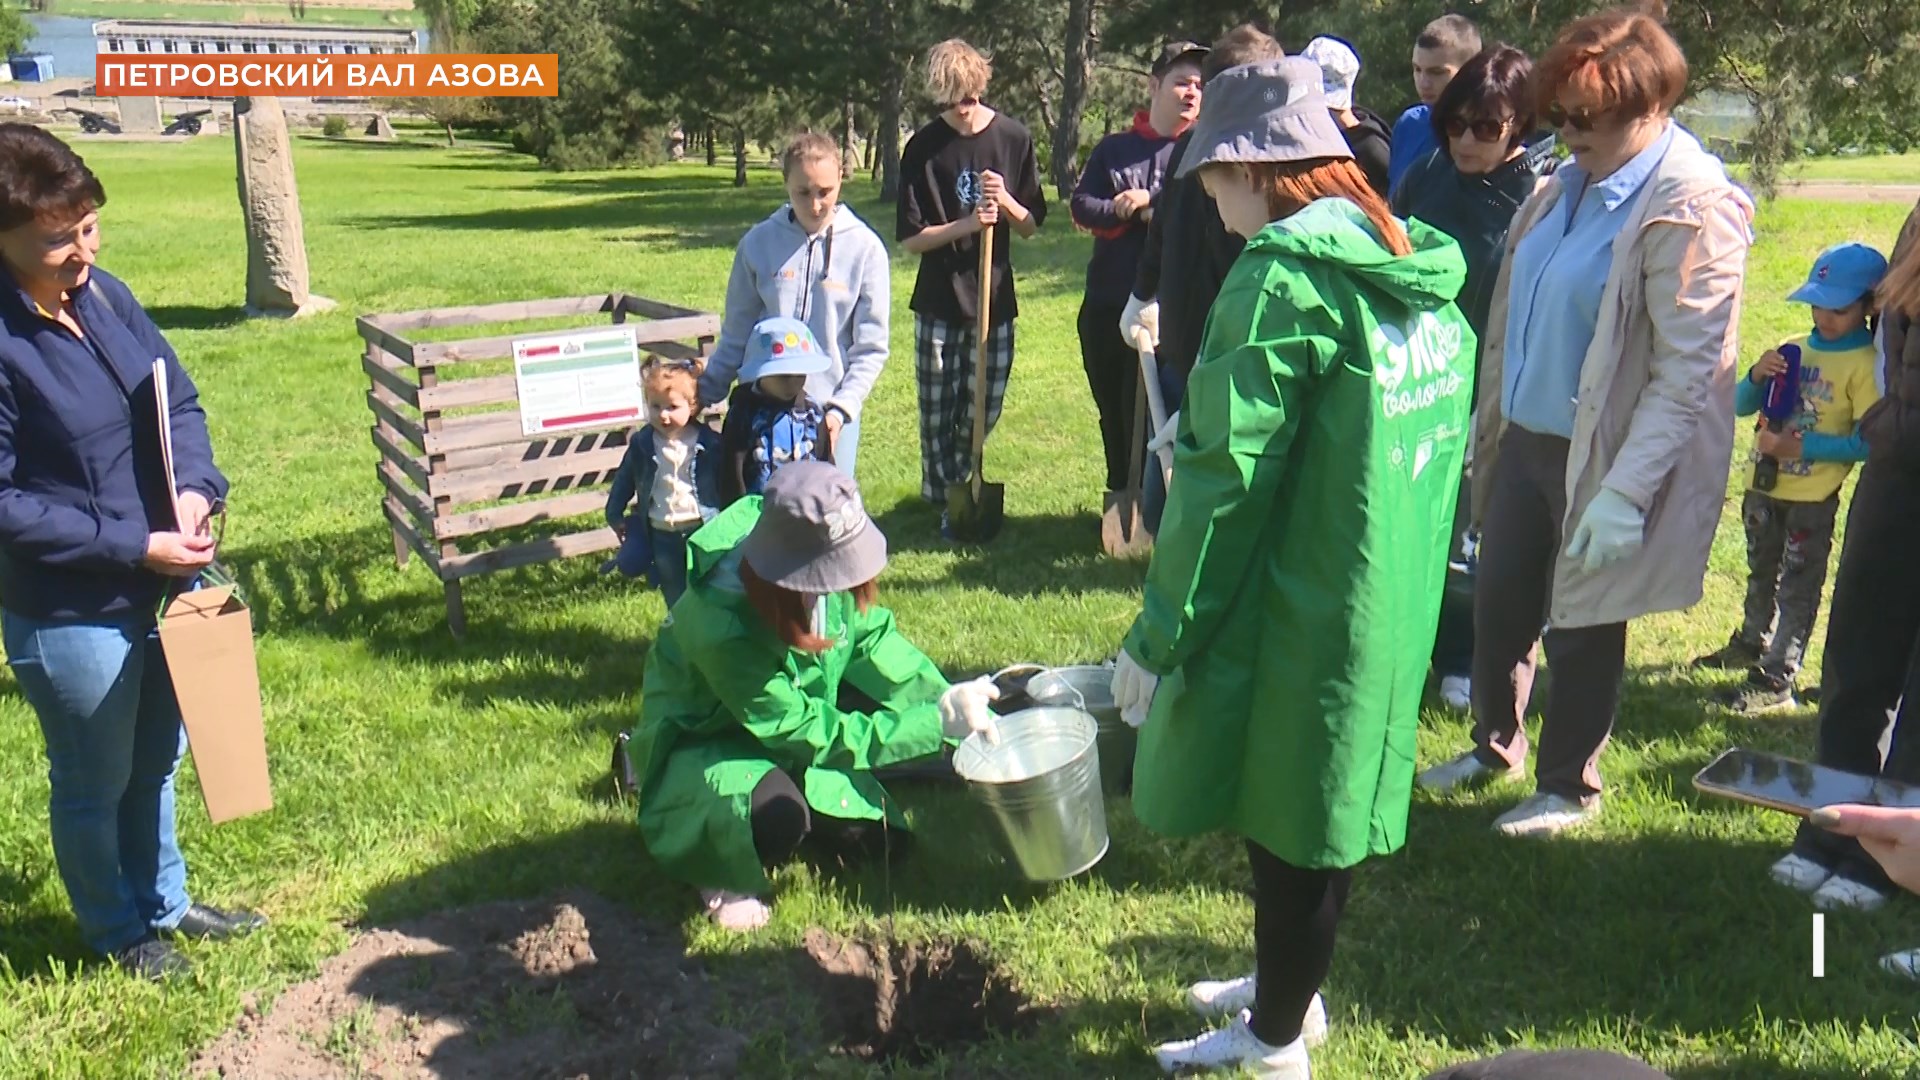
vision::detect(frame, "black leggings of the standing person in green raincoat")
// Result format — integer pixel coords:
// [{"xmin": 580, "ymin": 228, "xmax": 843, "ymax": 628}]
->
[{"xmin": 1246, "ymin": 840, "xmax": 1354, "ymax": 1045}]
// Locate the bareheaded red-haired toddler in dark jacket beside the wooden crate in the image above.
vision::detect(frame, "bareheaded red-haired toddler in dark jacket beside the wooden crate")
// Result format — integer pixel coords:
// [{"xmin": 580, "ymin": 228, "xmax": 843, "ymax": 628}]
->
[{"xmin": 603, "ymin": 357, "xmax": 720, "ymax": 607}]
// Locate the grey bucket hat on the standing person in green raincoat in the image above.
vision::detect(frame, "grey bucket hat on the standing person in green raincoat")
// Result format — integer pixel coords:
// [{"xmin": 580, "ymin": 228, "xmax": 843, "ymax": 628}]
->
[{"xmin": 1179, "ymin": 56, "xmax": 1354, "ymax": 177}]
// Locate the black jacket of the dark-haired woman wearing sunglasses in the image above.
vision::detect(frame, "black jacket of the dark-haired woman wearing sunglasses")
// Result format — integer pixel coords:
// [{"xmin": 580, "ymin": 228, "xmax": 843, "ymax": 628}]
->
[{"xmin": 1394, "ymin": 135, "xmax": 1559, "ymax": 357}]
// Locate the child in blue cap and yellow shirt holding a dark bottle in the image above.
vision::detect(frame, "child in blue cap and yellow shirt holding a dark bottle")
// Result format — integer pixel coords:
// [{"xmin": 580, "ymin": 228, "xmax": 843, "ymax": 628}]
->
[{"xmin": 1693, "ymin": 244, "xmax": 1887, "ymax": 713}]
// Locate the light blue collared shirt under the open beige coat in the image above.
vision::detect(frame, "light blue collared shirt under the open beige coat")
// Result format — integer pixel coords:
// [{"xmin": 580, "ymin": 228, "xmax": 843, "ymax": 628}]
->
[{"xmin": 1500, "ymin": 125, "xmax": 1678, "ymax": 438}]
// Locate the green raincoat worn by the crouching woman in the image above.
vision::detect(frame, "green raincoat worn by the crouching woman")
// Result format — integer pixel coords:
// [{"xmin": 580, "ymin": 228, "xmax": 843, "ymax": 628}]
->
[{"xmin": 628, "ymin": 496, "xmax": 947, "ymax": 894}]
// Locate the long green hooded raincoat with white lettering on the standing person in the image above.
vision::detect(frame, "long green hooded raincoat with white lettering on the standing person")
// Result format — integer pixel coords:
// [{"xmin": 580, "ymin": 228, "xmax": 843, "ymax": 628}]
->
[{"xmin": 1125, "ymin": 200, "xmax": 1475, "ymax": 869}]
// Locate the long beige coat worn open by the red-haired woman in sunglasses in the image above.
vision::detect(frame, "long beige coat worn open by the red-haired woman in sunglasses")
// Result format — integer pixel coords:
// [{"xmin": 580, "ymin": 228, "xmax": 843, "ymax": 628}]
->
[{"xmin": 1473, "ymin": 123, "xmax": 1753, "ymax": 626}]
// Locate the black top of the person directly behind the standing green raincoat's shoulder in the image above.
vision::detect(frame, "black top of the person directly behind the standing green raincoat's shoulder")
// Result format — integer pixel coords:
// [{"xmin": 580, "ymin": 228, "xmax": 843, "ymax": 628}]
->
[{"xmin": 1133, "ymin": 133, "xmax": 1246, "ymax": 382}]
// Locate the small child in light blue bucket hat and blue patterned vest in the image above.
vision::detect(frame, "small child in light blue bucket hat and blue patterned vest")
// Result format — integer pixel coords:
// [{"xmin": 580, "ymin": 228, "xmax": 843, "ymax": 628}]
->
[{"xmin": 720, "ymin": 315, "xmax": 833, "ymax": 507}]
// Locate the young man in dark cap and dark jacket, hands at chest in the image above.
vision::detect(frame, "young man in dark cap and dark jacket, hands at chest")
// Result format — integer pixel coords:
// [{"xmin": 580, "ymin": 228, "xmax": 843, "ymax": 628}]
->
[{"xmin": 1071, "ymin": 40, "xmax": 1208, "ymax": 492}]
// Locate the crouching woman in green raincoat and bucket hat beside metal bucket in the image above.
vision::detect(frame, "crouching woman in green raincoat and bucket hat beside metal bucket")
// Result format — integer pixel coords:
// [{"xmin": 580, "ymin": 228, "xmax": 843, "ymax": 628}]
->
[{"xmin": 628, "ymin": 461, "xmax": 996, "ymax": 930}]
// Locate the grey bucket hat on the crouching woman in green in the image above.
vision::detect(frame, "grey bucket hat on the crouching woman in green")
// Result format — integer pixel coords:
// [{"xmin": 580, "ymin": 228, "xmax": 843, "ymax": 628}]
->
[{"xmin": 739, "ymin": 453, "xmax": 887, "ymax": 594}]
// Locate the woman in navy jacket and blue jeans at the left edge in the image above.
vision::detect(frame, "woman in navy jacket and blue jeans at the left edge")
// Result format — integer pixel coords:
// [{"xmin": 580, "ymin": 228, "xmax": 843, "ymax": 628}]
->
[{"xmin": 0, "ymin": 123, "xmax": 263, "ymax": 978}]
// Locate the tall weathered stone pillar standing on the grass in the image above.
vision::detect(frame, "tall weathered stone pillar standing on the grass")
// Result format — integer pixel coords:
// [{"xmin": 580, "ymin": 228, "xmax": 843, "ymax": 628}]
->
[{"xmin": 234, "ymin": 98, "xmax": 334, "ymax": 319}]
